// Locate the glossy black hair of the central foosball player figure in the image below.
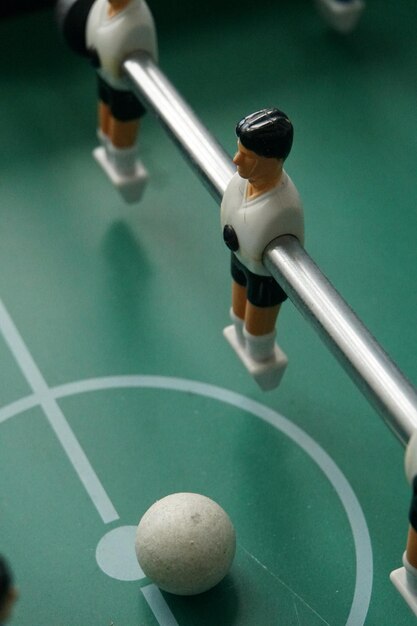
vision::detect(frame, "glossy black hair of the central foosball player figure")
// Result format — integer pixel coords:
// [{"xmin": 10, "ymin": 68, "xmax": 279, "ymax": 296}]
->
[{"xmin": 236, "ymin": 108, "xmax": 294, "ymax": 160}]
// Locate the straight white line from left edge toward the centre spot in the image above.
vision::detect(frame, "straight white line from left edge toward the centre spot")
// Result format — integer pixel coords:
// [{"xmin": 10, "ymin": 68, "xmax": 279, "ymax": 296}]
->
[{"xmin": 0, "ymin": 300, "xmax": 119, "ymax": 524}]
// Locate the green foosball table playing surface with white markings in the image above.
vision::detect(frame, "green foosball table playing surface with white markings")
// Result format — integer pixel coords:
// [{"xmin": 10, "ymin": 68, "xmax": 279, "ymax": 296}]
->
[{"xmin": 0, "ymin": 0, "xmax": 417, "ymax": 626}]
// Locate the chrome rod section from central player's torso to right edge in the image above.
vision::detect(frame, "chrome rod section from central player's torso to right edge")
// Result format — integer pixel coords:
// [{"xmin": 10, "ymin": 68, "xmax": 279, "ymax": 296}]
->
[{"xmin": 263, "ymin": 235, "xmax": 417, "ymax": 444}]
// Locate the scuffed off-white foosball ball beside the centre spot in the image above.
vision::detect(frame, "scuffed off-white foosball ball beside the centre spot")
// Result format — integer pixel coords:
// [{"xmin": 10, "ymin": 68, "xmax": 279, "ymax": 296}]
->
[{"xmin": 135, "ymin": 493, "xmax": 236, "ymax": 596}]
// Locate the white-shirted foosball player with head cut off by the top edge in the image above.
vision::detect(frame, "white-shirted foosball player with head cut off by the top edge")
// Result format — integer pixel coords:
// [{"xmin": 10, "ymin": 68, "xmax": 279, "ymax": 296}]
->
[{"xmin": 86, "ymin": 0, "xmax": 157, "ymax": 202}]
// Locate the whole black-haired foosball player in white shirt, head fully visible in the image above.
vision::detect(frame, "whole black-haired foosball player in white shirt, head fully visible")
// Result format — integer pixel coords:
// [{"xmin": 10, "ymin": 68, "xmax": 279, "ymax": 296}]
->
[{"xmin": 221, "ymin": 108, "xmax": 304, "ymax": 390}]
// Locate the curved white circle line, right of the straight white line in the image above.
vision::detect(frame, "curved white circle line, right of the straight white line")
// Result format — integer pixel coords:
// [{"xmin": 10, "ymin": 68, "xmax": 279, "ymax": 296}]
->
[{"xmin": 48, "ymin": 376, "xmax": 373, "ymax": 626}]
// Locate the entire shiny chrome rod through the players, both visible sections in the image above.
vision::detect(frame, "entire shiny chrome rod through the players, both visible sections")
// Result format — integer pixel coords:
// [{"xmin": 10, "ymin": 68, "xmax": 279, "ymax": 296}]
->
[{"xmin": 124, "ymin": 52, "xmax": 417, "ymax": 445}]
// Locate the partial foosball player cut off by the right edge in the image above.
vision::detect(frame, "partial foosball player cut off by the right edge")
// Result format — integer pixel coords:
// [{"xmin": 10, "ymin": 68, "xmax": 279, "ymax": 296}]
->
[{"xmin": 390, "ymin": 431, "xmax": 417, "ymax": 616}]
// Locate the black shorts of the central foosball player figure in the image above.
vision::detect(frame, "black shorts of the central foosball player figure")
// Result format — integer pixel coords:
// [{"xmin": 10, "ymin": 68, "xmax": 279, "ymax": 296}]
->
[{"xmin": 231, "ymin": 252, "xmax": 288, "ymax": 307}]
